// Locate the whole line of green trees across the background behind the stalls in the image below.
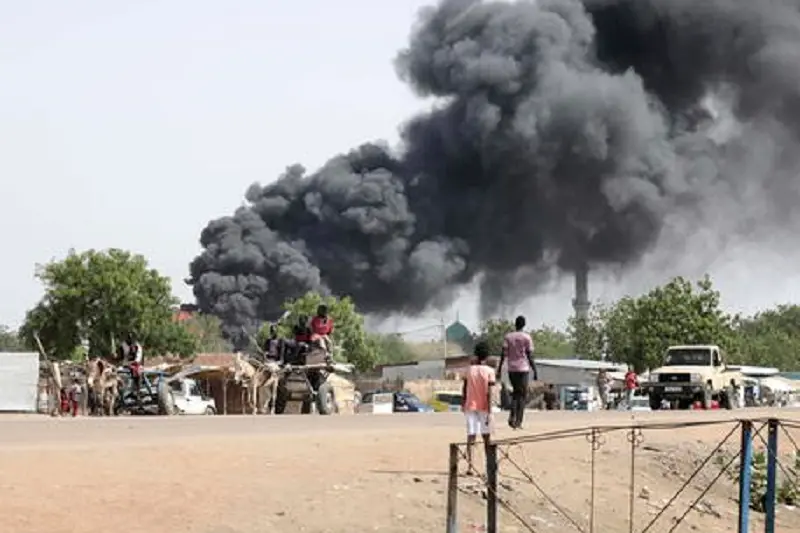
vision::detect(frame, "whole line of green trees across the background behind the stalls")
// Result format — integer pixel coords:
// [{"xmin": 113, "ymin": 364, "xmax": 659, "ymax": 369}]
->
[{"xmin": 0, "ymin": 249, "xmax": 800, "ymax": 371}]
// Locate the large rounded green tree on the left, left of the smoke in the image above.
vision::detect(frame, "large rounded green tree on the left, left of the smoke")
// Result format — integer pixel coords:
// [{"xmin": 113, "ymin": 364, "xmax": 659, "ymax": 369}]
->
[{"xmin": 21, "ymin": 249, "xmax": 196, "ymax": 359}]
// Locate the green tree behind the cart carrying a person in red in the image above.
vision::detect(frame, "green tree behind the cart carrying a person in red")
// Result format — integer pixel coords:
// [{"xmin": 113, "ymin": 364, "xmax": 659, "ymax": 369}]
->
[{"xmin": 258, "ymin": 292, "xmax": 378, "ymax": 370}]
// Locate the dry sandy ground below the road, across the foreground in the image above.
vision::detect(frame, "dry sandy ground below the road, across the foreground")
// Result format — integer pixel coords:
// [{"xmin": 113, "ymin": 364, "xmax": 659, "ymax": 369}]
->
[{"xmin": 0, "ymin": 410, "xmax": 800, "ymax": 533}]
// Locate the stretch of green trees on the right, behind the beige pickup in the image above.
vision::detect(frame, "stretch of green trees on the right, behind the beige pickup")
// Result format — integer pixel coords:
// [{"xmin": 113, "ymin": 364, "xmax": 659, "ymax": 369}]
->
[{"xmin": 481, "ymin": 276, "xmax": 800, "ymax": 372}]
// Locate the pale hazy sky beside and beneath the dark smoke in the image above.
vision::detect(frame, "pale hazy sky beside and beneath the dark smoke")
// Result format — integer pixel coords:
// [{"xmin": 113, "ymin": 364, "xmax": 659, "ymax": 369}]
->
[{"xmin": 0, "ymin": 0, "xmax": 800, "ymax": 336}]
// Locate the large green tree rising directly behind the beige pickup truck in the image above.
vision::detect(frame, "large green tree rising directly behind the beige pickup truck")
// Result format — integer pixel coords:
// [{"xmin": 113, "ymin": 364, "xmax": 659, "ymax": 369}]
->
[{"xmin": 600, "ymin": 276, "xmax": 735, "ymax": 371}]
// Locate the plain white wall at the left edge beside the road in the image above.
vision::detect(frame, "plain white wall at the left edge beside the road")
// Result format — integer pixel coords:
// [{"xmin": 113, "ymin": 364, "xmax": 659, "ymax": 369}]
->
[{"xmin": 0, "ymin": 353, "xmax": 39, "ymax": 412}]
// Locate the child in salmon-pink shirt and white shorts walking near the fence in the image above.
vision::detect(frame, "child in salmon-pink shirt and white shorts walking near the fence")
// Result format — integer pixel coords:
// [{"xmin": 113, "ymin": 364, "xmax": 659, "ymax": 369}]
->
[{"xmin": 461, "ymin": 342, "xmax": 496, "ymax": 475}]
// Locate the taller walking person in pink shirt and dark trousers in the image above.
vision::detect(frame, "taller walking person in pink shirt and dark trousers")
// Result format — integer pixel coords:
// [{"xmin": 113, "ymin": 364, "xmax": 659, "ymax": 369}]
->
[{"xmin": 497, "ymin": 316, "xmax": 536, "ymax": 429}]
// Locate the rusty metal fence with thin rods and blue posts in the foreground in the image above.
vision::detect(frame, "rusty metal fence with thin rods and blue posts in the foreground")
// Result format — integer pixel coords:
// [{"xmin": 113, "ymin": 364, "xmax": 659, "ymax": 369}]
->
[{"xmin": 447, "ymin": 418, "xmax": 800, "ymax": 533}]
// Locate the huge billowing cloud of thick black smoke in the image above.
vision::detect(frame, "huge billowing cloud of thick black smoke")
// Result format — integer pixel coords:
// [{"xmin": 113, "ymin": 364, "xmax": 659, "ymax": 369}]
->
[{"xmin": 189, "ymin": 0, "xmax": 800, "ymax": 340}]
